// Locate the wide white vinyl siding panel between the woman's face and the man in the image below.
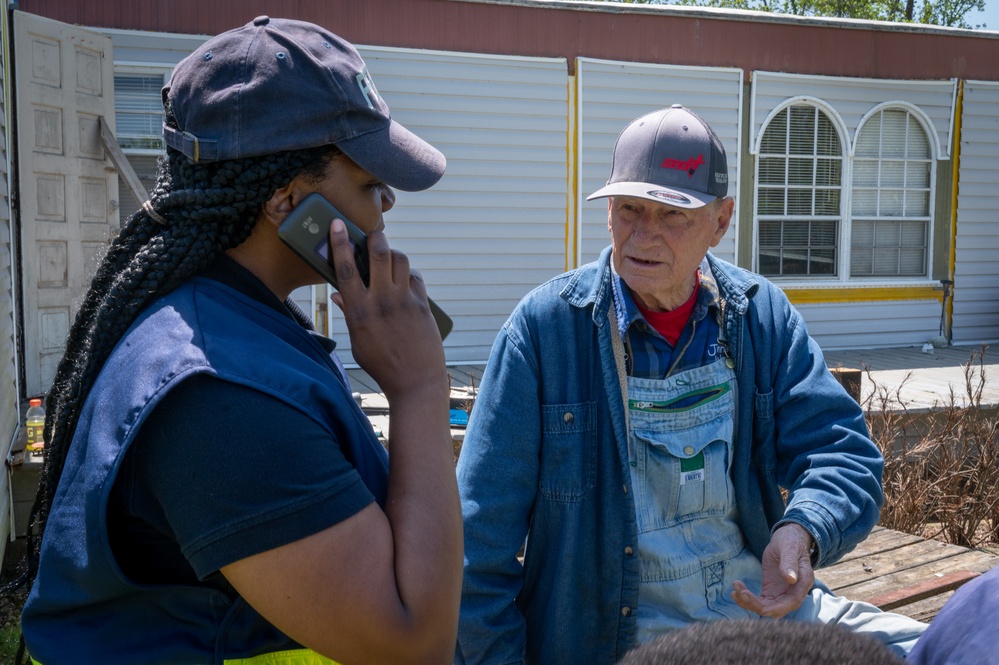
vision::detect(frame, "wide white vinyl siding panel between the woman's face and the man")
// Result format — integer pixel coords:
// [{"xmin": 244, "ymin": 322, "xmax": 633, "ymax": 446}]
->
[{"xmin": 346, "ymin": 46, "xmax": 568, "ymax": 364}]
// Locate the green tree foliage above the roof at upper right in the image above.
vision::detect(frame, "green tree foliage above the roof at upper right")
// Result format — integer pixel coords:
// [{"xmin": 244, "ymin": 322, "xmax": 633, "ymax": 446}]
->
[{"xmin": 598, "ymin": 0, "xmax": 985, "ymax": 28}]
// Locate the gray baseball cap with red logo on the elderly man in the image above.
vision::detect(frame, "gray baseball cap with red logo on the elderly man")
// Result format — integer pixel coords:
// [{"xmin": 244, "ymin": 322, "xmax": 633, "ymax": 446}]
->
[{"xmin": 586, "ymin": 104, "xmax": 728, "ymax": 208}]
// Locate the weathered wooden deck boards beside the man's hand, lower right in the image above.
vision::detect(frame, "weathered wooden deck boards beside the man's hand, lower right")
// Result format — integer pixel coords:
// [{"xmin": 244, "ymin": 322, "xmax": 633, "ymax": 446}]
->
[{"xmin": 816, "ymin": 527, "xmax": 999, "ymax": 621}]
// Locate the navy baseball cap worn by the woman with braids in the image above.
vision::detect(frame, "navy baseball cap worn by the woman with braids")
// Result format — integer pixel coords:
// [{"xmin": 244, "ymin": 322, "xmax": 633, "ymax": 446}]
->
[{"xmin": 162, "ymin": 16, "xmax": 446, "ymax": 191}]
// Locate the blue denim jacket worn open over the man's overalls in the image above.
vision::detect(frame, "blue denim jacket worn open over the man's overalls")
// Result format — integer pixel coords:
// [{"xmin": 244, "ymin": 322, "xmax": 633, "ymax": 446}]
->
[{"xmin": 455, "ymin": 248, "xmax": 883, "ymax": 665}]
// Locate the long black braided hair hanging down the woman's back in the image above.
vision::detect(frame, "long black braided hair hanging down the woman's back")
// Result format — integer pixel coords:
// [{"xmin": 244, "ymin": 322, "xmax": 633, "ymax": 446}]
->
[{"xmin": 0, "ymin": 114, "xmax": 341, "ymax": 593}]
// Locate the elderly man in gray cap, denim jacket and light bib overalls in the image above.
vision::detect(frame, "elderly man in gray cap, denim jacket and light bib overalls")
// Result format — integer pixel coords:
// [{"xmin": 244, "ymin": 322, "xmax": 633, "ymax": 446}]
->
[{"xmin": 456, "ymin": 106, "xmax": 925, "ymax": 665}]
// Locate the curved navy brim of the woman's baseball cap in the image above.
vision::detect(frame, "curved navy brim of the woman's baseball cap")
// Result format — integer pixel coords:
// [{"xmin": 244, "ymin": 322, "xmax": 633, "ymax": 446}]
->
[{"xmin": 336, "ymin": 120, "xmax": 447, "ymax": 192}]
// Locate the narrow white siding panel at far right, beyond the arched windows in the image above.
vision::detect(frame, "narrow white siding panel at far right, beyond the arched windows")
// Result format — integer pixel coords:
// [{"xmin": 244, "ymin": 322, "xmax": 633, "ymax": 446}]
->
[{"xmin": 953, "ymin": 81, "xmax": 999, "ymax": 344}]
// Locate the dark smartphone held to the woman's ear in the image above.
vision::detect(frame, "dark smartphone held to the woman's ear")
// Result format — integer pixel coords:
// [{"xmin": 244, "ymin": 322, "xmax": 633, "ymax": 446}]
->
[{"xmin": 278, "ymin": 192, "xmax": 454, "ymax": 340}]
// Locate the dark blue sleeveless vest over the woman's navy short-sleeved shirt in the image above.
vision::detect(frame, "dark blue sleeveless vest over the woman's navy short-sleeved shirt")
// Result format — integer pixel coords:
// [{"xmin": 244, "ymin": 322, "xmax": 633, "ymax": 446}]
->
[{"xmin": 22, "ymin": 278, "xmax": 388, "ymax": 665}]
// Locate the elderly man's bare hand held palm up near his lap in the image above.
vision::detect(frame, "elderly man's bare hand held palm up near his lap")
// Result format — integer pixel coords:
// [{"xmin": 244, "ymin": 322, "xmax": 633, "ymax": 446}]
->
[{"xmin": 732, "ymin": 524, "xmax": 815, "ymax": 619}]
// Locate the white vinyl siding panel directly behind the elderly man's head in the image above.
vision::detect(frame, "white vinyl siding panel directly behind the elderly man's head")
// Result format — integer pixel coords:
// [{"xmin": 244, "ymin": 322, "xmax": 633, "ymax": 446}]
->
[{"xmin": 576, "ymin": 58, "xmax": 743, "ymax": 264}]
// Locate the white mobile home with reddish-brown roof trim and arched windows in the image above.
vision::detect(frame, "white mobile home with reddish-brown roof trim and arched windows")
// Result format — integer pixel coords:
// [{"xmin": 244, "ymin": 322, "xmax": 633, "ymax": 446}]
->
[{"xmin": 0, "ymin": 0, "xmax": 999, "ymax": 560}]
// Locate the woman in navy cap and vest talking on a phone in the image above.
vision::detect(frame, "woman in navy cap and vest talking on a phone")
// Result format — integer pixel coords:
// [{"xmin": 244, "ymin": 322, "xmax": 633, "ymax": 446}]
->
[{"xmin": 16, "ymin": 17, "xmax": 462, "ymax": 665}]
